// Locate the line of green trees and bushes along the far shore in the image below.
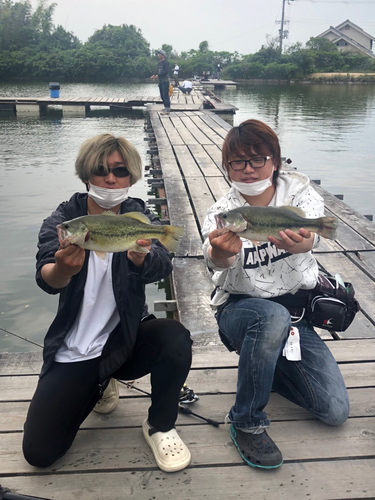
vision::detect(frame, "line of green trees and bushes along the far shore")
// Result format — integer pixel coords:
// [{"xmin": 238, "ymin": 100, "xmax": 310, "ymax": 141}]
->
[{"xmin": 0, "ymin": 0, "xmax": 375, "ymax": 82}]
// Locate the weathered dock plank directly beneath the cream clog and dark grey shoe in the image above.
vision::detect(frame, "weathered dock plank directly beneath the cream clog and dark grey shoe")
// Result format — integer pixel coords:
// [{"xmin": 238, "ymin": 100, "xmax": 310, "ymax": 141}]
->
[{"xmin": 0, "ymin": 418, "xmax": 375, "ymax": 475}]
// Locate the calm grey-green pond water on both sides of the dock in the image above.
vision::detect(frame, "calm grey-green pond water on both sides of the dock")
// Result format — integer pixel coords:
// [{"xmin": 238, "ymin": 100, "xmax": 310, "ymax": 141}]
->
[{"xmin": 0, "ymin": 83, "xmax": 375, "ymax": 352}]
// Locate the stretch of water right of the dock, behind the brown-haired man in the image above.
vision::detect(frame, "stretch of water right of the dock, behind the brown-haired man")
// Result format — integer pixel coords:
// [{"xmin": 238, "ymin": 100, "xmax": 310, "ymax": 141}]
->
[{"xmin": 217, "ymin": 84, "xmax": 375, "ymax": 215}]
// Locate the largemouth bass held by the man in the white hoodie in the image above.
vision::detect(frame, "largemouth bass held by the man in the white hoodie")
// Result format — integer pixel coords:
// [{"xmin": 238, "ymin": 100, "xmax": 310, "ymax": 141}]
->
[{"xmin": 215, "ymin": 206, "xmax": 338, "ymax": 242}]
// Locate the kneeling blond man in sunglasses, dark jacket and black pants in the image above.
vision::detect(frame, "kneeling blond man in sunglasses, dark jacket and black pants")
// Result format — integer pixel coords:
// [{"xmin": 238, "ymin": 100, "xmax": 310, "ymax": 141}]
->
[{"xmin": 23, "ymin": 134, "xmax": 192, "ymax": 472}]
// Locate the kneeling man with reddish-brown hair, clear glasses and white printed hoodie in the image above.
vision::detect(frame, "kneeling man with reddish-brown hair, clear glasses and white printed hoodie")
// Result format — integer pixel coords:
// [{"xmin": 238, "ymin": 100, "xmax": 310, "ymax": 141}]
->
[{"xmin": 203, "ymin": 120, "xmax": 349, "ymax": 469}]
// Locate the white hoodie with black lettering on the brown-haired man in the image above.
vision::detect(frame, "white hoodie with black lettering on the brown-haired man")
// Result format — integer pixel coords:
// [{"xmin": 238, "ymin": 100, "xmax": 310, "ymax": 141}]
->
[{"xmin": 202, "ymin": 171, "xmax": 324, "ymax": 307}]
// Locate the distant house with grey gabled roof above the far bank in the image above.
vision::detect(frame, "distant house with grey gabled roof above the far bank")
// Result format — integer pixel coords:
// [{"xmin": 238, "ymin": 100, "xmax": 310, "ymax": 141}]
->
[{"xmin": 318, "ymin": 19, "xmax": 375, "ymax": 59}]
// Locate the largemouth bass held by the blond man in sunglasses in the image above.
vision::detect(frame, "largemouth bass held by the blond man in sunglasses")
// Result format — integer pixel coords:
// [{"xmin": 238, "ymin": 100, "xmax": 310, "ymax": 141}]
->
[{"xmin": 57, "ymin": 211, "xmax": 184, "ymax": 258}]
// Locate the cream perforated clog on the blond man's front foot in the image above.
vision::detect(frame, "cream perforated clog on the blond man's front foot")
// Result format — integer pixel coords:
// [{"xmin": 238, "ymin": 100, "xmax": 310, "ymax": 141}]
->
[{"xmin": 142, "ymin": 418, "xmax": 191, "ymax": 472}]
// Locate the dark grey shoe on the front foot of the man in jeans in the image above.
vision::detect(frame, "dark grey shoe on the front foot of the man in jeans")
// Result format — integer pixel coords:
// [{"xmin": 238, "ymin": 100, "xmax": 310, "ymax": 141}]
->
[{"xmin": 229, "ymin": 424, "xmax": 283, "ymax": 469}]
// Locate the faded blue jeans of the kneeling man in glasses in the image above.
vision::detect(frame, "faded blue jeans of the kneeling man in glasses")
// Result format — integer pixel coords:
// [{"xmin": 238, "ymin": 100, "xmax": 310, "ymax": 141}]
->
[{"xmin": 216, "ymin": 295, "xmax": 349, "ymax": 430}]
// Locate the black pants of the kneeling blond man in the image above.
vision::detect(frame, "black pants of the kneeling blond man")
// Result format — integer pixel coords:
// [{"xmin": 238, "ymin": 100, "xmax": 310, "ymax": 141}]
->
[{"xmin": 23, "ymin": 319, "xmax": 192, "ymax": 467}]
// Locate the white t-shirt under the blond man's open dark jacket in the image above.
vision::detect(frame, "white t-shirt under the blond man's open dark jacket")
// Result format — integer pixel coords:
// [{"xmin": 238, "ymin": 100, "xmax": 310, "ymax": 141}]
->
[{"xmin": 55, "ymin": 252, "xmax": 120, "ymax": 363}]
